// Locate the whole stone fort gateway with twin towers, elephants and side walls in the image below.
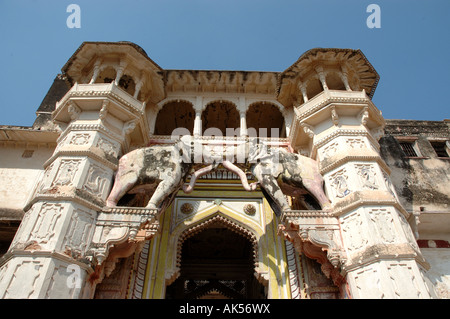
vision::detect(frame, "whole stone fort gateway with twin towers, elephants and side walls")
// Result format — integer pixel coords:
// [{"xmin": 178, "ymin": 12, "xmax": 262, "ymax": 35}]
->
[{"xmin": 0, "ymin": 42, "xmax": 450, "ymax": 299}]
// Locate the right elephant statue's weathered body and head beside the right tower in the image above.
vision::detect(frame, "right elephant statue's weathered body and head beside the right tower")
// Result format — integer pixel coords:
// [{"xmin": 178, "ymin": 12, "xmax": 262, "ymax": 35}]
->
[{"xmin": 241, "ymin": 142, "xmax": 331, "ymax": 215}]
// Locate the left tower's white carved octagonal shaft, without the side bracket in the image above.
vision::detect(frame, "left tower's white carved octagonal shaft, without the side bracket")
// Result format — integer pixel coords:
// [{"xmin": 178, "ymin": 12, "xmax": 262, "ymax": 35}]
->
[{"xmin": 0, "ymin": 92, "xmax": 142, "ymax": 299}]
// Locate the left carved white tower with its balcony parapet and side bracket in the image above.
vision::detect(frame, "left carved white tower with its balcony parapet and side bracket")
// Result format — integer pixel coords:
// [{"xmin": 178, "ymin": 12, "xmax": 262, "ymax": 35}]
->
[{"xmin": 0, "ymin": 83, "xmax": 148, "ymax": 298}]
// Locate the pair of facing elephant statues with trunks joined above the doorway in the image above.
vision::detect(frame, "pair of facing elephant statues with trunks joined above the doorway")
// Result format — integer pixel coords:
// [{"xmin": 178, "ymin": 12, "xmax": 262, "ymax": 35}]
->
[{"xmin": 106, "ymin": 139, "xmax": 331, "ymax": 215}]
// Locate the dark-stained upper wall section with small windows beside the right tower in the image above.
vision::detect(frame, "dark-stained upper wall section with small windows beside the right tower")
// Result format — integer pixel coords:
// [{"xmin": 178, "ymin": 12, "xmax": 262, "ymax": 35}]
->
[{"xmin": 380, "ymin": 120, "xmax": 450, "ymax": 213}]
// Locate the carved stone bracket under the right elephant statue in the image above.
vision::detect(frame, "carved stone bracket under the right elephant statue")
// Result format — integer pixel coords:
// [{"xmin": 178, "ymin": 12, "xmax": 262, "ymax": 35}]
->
[{"xmin": 279, "ymin": 210, "xmax": 346, "ymax": 285}]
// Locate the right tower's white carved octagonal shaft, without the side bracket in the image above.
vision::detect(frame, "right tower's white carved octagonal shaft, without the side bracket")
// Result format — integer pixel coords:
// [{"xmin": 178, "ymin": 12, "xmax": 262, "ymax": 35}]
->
[{"xmin": 313, "ymin": 99, "xmax": 435, "ymax": 299}]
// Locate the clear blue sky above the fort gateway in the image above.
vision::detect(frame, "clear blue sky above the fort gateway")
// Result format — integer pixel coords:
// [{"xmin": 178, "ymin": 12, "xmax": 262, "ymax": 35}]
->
[{"xmin": 0, "ymin": 0, "xmax": 450, "ymax": 126}]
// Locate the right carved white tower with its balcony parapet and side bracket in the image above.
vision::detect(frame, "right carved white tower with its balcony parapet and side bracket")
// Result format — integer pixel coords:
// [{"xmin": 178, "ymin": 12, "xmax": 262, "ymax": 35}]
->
[{"xmin": 285, "ymin": 91, "xmax": 434, "ymax": 298}]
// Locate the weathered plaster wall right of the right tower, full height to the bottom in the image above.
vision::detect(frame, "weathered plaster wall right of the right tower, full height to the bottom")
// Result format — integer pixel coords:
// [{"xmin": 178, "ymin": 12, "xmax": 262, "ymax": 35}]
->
[{"xmin": 380, "ymin": 120, "xmax": 450, "ymax": 298}]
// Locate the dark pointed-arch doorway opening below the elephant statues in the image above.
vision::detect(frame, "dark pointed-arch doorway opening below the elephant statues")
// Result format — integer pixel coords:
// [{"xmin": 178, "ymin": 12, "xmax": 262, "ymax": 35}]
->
[{"xmin": 166, "ymin": 218, "xmax": 267, "ymax": 299}]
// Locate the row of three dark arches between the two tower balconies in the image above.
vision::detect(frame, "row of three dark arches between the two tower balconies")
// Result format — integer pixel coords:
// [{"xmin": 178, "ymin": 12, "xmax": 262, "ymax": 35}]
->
[{"xmin": 153, "ymin": 97, "xmax": 290, "ymax": 138}]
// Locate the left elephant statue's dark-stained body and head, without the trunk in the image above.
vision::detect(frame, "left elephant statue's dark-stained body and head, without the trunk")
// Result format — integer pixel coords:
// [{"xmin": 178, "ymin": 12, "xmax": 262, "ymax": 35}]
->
[{"xmin": 106, "ymin": 142, "xmax": 192, "ymax": 210}]
